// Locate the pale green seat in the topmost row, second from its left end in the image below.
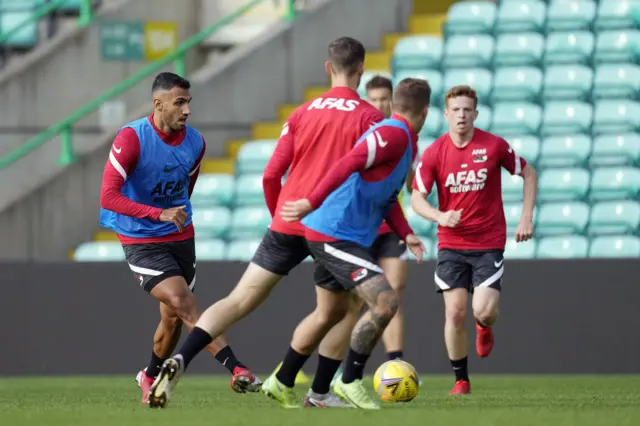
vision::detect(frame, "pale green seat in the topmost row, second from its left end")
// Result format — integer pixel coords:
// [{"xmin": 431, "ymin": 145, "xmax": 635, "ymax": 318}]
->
[{"xmin": 494, "ymin": 0, "xmax": 547, "ymax": 34}]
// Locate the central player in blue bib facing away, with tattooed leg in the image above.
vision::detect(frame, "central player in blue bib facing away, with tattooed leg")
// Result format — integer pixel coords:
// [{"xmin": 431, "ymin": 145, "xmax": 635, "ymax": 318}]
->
[{"xmin": 263, "ymin": 78, "xmax": 431, "ymax": 409}]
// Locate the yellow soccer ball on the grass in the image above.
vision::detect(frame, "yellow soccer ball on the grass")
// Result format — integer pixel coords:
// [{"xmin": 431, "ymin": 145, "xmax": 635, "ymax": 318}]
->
[{"xmin": 373, "ymin": 359, "xmax": 420, "ymax": 402}]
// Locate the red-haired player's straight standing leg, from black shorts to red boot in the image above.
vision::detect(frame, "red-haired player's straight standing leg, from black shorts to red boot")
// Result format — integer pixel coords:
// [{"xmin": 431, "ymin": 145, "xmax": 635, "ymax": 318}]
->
[{"xmin": 434, "ymin": 249, "xmax": 471, "ymax": 395}]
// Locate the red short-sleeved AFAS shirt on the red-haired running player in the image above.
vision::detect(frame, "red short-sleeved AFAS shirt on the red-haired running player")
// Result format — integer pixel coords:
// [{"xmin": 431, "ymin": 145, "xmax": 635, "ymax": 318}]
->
[{"xmin": 413, "ymin": 129, "xmax": 527, "ymax": 250}]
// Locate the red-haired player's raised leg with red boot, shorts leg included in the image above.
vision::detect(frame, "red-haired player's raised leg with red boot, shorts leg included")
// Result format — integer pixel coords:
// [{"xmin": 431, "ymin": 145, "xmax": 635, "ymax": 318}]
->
[{"xmin": 470, "ymin": 250, "xmax": 504, "ymax": 358}]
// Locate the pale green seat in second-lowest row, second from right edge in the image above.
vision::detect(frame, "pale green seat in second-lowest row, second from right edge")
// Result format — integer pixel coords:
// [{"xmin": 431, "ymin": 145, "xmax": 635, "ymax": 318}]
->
[{"xmin": 536, "ymin": 202, "xmax": 589, "ymax": 237}]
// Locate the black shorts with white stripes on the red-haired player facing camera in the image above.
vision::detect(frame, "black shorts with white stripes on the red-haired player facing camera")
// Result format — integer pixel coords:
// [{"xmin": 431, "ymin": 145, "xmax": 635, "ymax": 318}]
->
[{"xmin": 435, "ymin": 249, "xmax": 504, "ymax": 293}]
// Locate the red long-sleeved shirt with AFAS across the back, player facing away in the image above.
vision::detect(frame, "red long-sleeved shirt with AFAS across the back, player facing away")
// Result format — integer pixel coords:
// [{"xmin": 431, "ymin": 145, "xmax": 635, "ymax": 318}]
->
[{"xmin": 262, "ymin": 87, "xmax": 384, "ymax": 236}]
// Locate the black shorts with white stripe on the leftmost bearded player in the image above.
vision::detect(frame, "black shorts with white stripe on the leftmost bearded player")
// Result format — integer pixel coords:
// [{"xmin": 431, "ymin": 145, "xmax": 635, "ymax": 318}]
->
[{"xmin": 122, "ymin": 238, "xmax": 196, "ymax": 292}]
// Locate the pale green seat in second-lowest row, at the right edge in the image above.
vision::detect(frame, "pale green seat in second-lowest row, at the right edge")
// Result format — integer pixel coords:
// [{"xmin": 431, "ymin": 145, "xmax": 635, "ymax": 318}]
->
[{"xmin": 588, "ymin": 200, "xmax": 640, "ymax": 235}]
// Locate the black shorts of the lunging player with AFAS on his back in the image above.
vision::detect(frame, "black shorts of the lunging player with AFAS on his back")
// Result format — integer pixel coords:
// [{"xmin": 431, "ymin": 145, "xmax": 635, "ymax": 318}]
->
[{"xmin": 251, "ymin": 229, "xmax": 310, "ymax": 275}]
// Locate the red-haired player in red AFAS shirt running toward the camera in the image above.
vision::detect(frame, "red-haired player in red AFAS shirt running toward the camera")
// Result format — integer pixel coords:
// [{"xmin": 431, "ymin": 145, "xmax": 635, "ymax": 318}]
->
[{"xmin": 411, "ymin": 86, "xmax": 538, "ymax": 395}]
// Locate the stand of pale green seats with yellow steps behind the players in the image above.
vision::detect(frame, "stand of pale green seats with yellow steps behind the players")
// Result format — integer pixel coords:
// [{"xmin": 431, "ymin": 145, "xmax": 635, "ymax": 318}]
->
[{"xmin": 69, "ymin": 0, "xmax": 640, "ymax": 261}]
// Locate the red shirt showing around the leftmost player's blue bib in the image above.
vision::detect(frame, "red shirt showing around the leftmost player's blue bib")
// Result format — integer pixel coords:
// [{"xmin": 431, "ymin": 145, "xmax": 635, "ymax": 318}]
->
[{"xmin": 100, "ymin": 114, "xmax": 206, "ymax": 244}]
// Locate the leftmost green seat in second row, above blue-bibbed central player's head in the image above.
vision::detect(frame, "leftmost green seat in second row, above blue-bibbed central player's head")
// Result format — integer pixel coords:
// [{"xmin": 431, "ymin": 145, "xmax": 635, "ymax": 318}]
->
[{"xmin": 392, "ymin": 36, "xmax": 444, "ymax": 73}]
